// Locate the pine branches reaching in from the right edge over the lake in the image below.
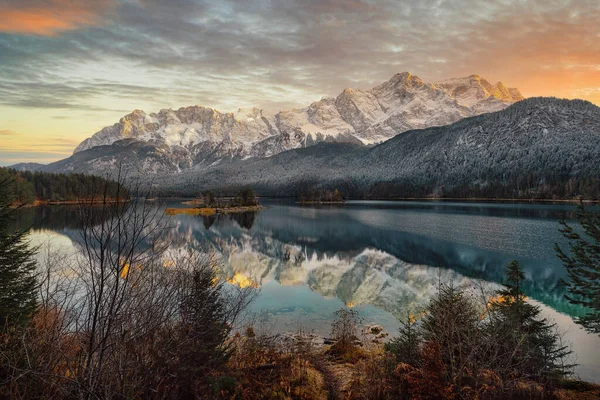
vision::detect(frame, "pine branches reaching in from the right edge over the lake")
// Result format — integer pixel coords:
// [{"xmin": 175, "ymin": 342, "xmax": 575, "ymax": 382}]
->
[{"xmin": 555, "ymin": 205, "xmax": 600, "ymax": 334}]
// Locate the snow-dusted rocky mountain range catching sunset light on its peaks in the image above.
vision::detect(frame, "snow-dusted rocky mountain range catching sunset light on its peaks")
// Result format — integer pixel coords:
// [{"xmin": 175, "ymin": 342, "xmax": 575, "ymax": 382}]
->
[{"xmin": 48, "ymin": 72, "xmax": 523, "ymax": 174}]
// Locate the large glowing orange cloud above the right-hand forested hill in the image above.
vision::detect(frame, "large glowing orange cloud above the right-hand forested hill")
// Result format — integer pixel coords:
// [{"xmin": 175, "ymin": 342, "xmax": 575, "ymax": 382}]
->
[{"xmin": 446, "ymin": 9, "xmax": 600, "ymax": 105}]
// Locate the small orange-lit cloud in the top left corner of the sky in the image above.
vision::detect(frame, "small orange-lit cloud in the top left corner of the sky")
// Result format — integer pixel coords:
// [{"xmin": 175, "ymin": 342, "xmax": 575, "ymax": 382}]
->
[{"xmin": 0, "ymin": 0, "xmax": 111, "ymax": 36}]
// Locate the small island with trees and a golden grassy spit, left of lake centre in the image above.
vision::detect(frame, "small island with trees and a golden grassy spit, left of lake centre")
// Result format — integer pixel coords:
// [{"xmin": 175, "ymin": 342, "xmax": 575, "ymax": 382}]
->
[{"xmin": 165, "ymin": 189, "xmax": 263, "ymax": 216}]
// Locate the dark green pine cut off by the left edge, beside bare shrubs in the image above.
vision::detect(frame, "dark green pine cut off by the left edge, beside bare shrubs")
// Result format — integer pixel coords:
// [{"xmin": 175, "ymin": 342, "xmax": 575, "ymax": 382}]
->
[{"xmin": 0, "ymin": 174, "xmax": 37, "ymax": 327}]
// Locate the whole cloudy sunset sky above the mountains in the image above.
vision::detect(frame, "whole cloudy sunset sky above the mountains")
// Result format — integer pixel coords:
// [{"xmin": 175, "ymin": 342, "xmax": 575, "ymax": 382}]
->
[{"xmin": 0, "ymin": 0, "xmax": 600, "ymax": 165}]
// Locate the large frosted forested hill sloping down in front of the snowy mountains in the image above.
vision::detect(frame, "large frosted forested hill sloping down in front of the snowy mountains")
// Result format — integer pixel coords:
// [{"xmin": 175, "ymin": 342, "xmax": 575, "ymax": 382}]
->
[{"xmin": 155, "ymin": 98, "xmax": 600, "ymax": 199}]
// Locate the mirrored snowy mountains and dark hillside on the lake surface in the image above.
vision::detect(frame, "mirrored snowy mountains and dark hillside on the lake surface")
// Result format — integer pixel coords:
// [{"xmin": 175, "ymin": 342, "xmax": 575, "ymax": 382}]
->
[{"xmin": 17, "ymin": 201, "xmax": 581, "ymax": 315}]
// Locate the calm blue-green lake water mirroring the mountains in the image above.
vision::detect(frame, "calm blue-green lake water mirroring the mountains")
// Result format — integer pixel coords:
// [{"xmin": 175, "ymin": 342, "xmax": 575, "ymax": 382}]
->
[{"xmin": 18, "ymin": 199, "xmax": 600, "ymax": 382}]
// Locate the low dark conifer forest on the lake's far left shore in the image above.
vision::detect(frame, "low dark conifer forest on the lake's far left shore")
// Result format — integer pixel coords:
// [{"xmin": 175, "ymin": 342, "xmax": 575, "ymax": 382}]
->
[{"xmin": 0, "ymin": 168, "xmax": 124, "ymax": 204}]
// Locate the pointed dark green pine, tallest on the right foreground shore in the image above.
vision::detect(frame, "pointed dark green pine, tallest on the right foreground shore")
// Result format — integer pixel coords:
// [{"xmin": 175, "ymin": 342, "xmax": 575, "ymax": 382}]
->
[{"xmin": 489, "ymin": 261, "xmax": 573, "ymax": 382}]
